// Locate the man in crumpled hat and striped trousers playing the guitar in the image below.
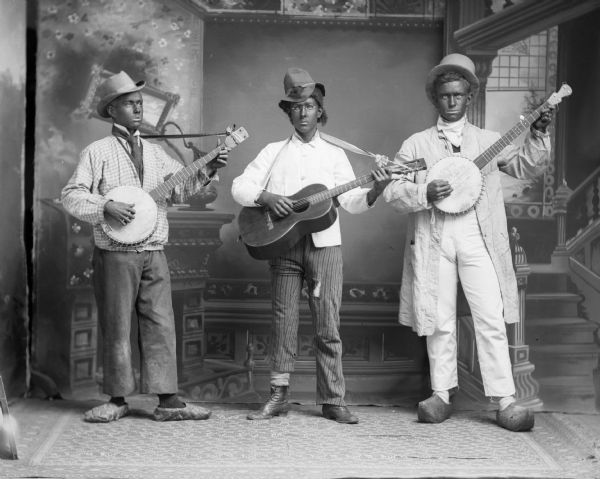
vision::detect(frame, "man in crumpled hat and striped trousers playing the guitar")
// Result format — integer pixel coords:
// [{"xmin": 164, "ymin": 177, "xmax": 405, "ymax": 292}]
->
[{"xmin": 231, "ymin": 68, "xmax": 389, "ymax": 424}]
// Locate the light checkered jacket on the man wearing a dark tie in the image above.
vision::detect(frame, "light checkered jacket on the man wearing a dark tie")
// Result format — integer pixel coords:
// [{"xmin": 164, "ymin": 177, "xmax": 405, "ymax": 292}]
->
[{"xmin": 61, "ymin": 136, "xmax": 210, "ymax": 251}]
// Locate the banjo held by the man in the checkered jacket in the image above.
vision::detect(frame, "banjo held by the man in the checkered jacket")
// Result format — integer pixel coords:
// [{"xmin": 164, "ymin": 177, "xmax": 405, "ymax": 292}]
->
[{"xmin": 101, "ymin": 127, "xmax": 248, "ymax": 246}]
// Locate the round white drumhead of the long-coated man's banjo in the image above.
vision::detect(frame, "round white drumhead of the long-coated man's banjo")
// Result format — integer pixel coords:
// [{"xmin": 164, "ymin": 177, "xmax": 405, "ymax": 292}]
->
[{"xmin": 426, "ymin": 156, "xmax": 483, "ymax": 214}]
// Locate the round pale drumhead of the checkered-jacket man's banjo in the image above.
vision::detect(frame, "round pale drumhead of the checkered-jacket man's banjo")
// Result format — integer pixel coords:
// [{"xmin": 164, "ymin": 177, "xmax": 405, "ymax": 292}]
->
[{"xmin": 102, "ymin": 186, "xmax": 158, "ymax": 245}]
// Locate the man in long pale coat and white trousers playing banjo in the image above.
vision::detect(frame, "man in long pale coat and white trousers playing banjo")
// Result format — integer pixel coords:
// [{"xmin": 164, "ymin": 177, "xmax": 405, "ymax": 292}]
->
[{"xmin": 383, "ymin": 53, "xmax": 552, "ymax": 431}]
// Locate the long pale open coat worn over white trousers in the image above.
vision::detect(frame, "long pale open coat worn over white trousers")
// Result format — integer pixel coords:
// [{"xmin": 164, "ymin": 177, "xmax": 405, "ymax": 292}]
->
[{"xmin": 383, "ymin": 122, "xmax": 550, "ymax": 336}]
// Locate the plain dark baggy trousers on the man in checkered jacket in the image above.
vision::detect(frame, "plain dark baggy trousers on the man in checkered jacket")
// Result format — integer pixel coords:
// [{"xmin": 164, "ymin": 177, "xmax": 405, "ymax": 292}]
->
[{"xmin": 93, "ymin": 248, "xmax": 177, "ymax": 396}]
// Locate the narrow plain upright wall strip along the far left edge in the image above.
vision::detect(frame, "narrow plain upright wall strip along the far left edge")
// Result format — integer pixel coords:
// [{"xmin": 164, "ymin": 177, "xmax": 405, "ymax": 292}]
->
[{"xmin": 0, "ymin": 0, "xmax": 28, "ymax": 397}]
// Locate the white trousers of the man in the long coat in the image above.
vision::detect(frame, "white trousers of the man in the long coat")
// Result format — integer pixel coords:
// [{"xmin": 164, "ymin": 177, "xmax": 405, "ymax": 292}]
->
[{"xmin": 427, "ymin": 212, "xmax": 515, "ymax": 397}]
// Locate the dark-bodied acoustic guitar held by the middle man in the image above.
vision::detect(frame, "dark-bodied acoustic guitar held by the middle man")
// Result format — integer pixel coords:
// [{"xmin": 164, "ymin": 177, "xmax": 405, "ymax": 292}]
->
[{"xmin": 238, "ymin": 158, "xmax": 426, "ymax": 259}]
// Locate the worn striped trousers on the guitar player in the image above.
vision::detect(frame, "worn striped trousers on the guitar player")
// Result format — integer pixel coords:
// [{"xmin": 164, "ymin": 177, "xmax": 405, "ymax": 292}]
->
[{"xmin": 269, "ymin": 235, "xmax": 346, "ymax": 406}]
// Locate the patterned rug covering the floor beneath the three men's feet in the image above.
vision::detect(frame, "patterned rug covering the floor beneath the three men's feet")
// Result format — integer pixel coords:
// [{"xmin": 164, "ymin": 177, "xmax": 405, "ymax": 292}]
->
[{"xmin": 0, "ymin": 397, "xmax": 600, "ymax": 479}]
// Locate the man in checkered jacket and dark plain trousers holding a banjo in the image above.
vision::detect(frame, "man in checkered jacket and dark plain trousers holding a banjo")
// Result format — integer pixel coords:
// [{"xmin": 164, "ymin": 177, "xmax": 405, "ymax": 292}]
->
[{"xmin": 61, "ymin": 71, "xmax": 227, "ymax": 422}]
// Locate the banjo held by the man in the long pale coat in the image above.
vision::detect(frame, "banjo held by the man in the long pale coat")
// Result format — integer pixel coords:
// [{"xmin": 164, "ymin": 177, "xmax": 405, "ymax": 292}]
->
[{"xmin": 425, "ymin": 83, "xmax": 572, "ymax": 215}]
